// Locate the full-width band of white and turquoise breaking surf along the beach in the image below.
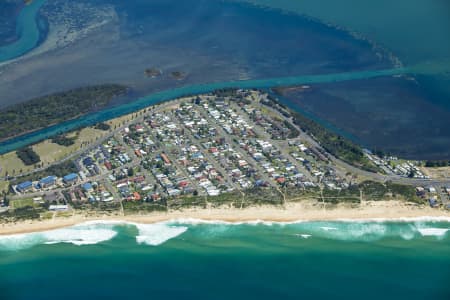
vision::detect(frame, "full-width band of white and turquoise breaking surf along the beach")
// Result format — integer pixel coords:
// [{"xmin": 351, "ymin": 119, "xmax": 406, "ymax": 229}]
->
[{"xmin": 0, "ymin": 218, "xmax": 450, "ymax": 251}]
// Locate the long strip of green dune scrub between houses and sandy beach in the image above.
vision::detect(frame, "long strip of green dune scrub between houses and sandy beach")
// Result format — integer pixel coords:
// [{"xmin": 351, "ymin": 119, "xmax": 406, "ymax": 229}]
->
[{"xmin": 0, "ymin": 180, "xmax": 424, "ymax": 223}]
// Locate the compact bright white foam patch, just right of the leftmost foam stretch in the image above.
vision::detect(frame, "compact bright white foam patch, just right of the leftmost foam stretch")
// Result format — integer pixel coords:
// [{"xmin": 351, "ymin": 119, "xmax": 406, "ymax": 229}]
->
[{"xmin": 134, "ymin": 223, "xmax": 188, "ymax": 246}]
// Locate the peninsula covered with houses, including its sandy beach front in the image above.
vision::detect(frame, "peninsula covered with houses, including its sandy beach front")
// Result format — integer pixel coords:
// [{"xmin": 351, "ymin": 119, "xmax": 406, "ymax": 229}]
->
[{"xmin": 0, "ymin": 89, "xmax": 450, "ymax": 233}]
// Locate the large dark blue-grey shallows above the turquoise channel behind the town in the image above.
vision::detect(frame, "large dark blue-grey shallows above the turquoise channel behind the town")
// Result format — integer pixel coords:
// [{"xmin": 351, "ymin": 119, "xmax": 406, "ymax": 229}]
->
[{"xmin": 0, "ymin": 0, "xmax": 391, "ymax": 106}]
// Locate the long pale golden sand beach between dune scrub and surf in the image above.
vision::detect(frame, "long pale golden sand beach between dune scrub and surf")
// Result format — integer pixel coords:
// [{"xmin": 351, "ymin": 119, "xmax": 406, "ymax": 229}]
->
[{"xmin": 0, "ymin": 201, "xmax": 450, "ymax": 237}]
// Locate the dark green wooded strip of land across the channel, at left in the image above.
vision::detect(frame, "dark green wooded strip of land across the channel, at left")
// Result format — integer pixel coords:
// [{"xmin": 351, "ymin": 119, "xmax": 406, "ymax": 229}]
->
[{"xmin": 0, "ymin": 84, "xmax": 127, "ymax": 140}]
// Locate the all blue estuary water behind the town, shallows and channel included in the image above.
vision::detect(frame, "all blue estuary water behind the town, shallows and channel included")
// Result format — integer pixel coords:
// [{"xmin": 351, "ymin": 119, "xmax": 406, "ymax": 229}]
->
[{"xmin": 0, "ymin": 0, "xmax": 450, "ymax": 159}]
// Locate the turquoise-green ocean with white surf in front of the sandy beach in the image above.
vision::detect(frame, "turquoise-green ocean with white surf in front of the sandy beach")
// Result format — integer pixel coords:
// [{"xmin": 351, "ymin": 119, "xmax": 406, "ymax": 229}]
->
[{"xmin": 0, "ymin": 219, "xmax": 450, "ymax": 300}]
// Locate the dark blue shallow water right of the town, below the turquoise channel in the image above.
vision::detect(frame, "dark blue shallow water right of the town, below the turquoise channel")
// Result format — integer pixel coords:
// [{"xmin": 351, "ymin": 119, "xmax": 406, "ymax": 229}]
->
[{"xmin": 285, "ymin": 77, "xmax": 450, "ymax": 159}]
